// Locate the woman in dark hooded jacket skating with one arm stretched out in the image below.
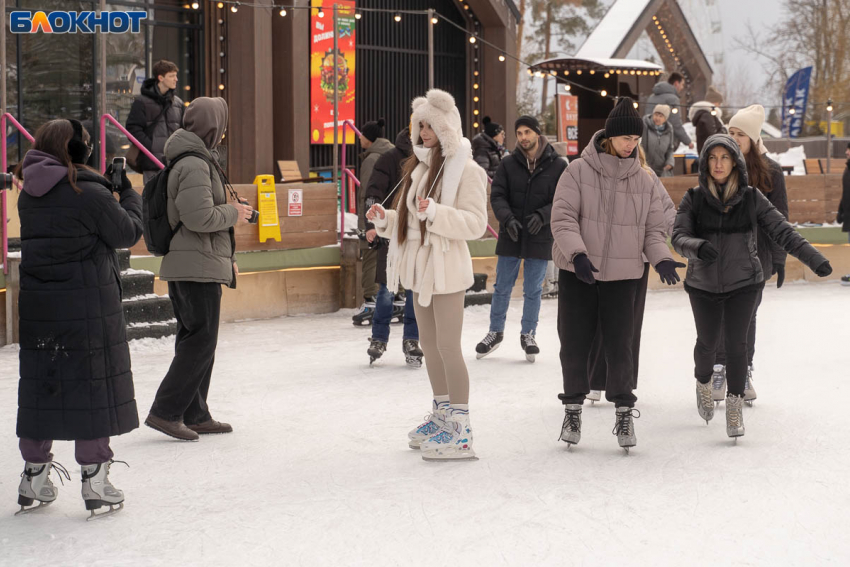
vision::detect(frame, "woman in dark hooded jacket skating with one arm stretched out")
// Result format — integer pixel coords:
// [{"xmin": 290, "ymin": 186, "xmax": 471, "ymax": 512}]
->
[{"xmin": 673, "ymin": 134, "xmax": 832, "ymax": 437}]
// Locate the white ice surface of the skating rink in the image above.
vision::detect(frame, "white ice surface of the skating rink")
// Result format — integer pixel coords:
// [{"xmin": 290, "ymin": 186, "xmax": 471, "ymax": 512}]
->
[{"xmin": 0, "ymin": 283, "xmax": 850, "ymax": 567}]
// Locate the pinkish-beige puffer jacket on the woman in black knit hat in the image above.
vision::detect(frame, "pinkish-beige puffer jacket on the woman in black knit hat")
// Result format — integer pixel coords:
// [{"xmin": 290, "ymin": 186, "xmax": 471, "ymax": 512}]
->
[{"xmin": 552, "ymin": 130, "xmax": 673, "ymax": 281}]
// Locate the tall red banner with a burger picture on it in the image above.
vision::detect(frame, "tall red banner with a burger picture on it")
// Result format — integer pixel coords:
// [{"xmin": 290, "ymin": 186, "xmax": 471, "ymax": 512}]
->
[{"xmin": 310, "ymin": 0, "xmax": 357, "ymax": 144}]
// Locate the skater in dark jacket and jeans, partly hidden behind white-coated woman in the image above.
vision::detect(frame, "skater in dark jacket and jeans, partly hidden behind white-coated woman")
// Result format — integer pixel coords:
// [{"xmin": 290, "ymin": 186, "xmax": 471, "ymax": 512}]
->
[{"xmin": 365, "ymin": 128, "xmax": 423, "ymax": 368}]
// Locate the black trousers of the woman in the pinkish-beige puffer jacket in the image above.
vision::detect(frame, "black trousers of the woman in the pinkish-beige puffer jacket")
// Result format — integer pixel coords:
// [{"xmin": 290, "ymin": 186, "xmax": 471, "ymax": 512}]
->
[{"xmin": 558, "ymin": 270, "xmax": 640, "ymax": 407}]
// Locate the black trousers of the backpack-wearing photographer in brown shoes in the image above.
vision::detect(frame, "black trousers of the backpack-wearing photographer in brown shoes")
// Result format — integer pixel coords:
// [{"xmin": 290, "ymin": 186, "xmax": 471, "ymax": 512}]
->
[{"xmin": 151, "ymin": 282, "xmax": 221, "ymax": 425}]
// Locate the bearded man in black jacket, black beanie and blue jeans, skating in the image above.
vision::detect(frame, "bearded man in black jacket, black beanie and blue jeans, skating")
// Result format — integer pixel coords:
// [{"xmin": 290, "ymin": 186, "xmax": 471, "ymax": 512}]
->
[{"xmin": 475, "ymin": 116, "xmax": 567, "ymax": 362}]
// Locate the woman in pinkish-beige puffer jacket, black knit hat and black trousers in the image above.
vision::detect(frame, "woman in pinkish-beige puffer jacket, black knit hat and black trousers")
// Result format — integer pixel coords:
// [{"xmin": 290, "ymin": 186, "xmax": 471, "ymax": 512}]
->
[{"xmin": 552, "ymin": 98, "xmax": 684, "ymax": 450}]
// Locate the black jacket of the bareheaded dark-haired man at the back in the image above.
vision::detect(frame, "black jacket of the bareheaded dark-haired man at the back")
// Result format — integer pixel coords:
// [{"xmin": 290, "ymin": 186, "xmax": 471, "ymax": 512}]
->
[{"xmin": 126, "ymin": 77, "xmax": 184, "ymax": 173}]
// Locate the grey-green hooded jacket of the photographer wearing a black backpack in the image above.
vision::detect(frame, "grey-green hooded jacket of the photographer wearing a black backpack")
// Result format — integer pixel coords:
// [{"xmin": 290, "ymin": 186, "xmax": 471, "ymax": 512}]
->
[{"xmin": 159, "ymin": 97, "xmax": 238, "ymax": 287}]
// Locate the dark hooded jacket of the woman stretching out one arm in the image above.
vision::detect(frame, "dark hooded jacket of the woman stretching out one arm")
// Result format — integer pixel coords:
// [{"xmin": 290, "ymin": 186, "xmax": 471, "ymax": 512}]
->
[{"xmin": 673, "ymin": 134, "xmax": 826, "ymax": 294}]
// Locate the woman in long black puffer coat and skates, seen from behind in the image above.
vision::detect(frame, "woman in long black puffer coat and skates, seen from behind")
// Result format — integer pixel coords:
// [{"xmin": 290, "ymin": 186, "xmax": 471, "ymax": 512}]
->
[{"xmin": 12, "ymin": 119, "xmax": 142, "ymax": 513}]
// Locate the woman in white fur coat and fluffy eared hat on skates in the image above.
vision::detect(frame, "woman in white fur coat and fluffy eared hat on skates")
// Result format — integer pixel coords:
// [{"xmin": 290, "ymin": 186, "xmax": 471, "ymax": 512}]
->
[{"xmin": 366, "ymin": 89, "xmax": 487, "ymax": 461}]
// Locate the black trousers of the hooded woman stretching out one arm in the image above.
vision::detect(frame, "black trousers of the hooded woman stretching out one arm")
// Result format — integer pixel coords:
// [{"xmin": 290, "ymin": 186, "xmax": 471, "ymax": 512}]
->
[{"xmin": 688, "ymin": 289, "xmax": 761, "ymax": 396}]
